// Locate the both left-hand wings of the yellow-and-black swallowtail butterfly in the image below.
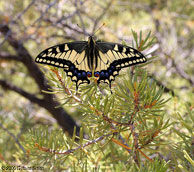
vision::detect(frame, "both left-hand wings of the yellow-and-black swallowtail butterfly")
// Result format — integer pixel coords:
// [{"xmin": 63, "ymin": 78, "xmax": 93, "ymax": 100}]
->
[{"xmin": 35, "ymin": 41, "xmax": 90, "ymax": 88}]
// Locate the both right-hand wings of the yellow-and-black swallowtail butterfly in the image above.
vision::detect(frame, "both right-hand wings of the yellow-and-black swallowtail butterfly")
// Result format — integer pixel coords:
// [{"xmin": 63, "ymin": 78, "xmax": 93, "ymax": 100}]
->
[{"xmin": 96, "ymin": 41, "xmax": 147, "ymax": 87}]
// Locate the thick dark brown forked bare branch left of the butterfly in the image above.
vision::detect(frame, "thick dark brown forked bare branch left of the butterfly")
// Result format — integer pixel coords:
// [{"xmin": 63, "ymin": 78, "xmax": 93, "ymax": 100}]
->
[{"xmin": 0, "ymin": 24, "xmax": 79, "ymax": 134}]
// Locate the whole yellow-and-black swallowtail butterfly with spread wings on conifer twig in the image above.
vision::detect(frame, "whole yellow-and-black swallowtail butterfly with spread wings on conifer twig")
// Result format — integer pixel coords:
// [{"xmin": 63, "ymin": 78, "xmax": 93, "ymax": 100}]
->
[{"xmin": 35, "ymin": 36, "xmax": 147, "ymax": 90}]
